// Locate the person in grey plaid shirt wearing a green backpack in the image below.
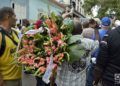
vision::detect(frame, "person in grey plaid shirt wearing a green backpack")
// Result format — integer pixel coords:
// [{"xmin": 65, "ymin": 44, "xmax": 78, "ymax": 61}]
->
[{"xmin": 56, "ymin": 20, "xmax": 98, "ymax": 86}]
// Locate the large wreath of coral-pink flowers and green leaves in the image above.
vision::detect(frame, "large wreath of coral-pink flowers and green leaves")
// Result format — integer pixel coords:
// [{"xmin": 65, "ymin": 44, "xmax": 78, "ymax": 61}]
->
[{"xmin": 17, "ymin": 13, "xmax": 73, "ymax": 76}]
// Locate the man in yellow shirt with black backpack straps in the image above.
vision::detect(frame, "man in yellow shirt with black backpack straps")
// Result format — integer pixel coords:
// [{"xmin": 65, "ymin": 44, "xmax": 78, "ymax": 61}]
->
[{"xmin": 0, "ymin": 7, "xmax": 22, "ymax": 86}]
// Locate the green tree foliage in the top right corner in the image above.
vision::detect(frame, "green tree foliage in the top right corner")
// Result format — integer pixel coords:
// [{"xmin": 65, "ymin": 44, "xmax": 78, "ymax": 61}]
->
[{"xmin": 83, "ymin": 0, "xmax": 120, "ymax": 19}]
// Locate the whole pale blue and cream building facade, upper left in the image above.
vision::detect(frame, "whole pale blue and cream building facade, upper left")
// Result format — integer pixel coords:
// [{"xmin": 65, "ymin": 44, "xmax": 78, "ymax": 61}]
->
[{"xmin": 0, "ymin": 0, "xmax": 64, "ymax": 21}]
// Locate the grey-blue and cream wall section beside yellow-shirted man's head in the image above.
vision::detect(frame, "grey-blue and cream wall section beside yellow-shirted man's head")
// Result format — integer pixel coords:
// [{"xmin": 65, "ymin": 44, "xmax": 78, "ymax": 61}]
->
[{"xmin": 0, "ymin": 0, "xmax": 28, "ymax": 23}]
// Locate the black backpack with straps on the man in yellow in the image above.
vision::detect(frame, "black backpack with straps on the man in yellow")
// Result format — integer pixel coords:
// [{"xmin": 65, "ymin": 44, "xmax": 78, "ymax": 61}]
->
[{"xmin": 0, "ymin": 27, "xmax": 18, "ymax": 57}]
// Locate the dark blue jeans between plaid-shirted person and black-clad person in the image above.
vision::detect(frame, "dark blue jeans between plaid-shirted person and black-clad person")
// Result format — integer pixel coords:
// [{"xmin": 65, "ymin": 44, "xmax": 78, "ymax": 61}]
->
[{"xmin": 86, "ymin": 63, "xmax": 95, "ymax": 86}]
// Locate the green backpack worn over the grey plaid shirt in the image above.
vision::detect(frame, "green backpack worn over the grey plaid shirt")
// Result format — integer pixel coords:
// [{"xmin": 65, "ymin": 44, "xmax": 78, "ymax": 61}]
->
[{"xmin": 68, "ymin": 35, "xmax": 89, "ymax": 63}]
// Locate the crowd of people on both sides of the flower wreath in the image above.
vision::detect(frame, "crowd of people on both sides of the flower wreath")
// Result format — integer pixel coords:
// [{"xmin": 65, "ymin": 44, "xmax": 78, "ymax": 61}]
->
[{"xmin": 0, "ymin": 7, "xmax": 120, "ymax": 86}]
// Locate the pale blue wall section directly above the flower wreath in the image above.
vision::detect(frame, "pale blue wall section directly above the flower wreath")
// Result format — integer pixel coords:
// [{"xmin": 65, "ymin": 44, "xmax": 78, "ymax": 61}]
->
[{"xmin": 29, "ymin": 0, "xmax": 63, "ymax": 20}]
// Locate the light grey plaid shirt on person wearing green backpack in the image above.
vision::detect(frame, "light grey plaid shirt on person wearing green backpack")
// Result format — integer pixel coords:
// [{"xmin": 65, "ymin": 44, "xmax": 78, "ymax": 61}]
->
[{"xmin": 56, "ymin": 38, "xmax": 98, "ymax": 86}]
